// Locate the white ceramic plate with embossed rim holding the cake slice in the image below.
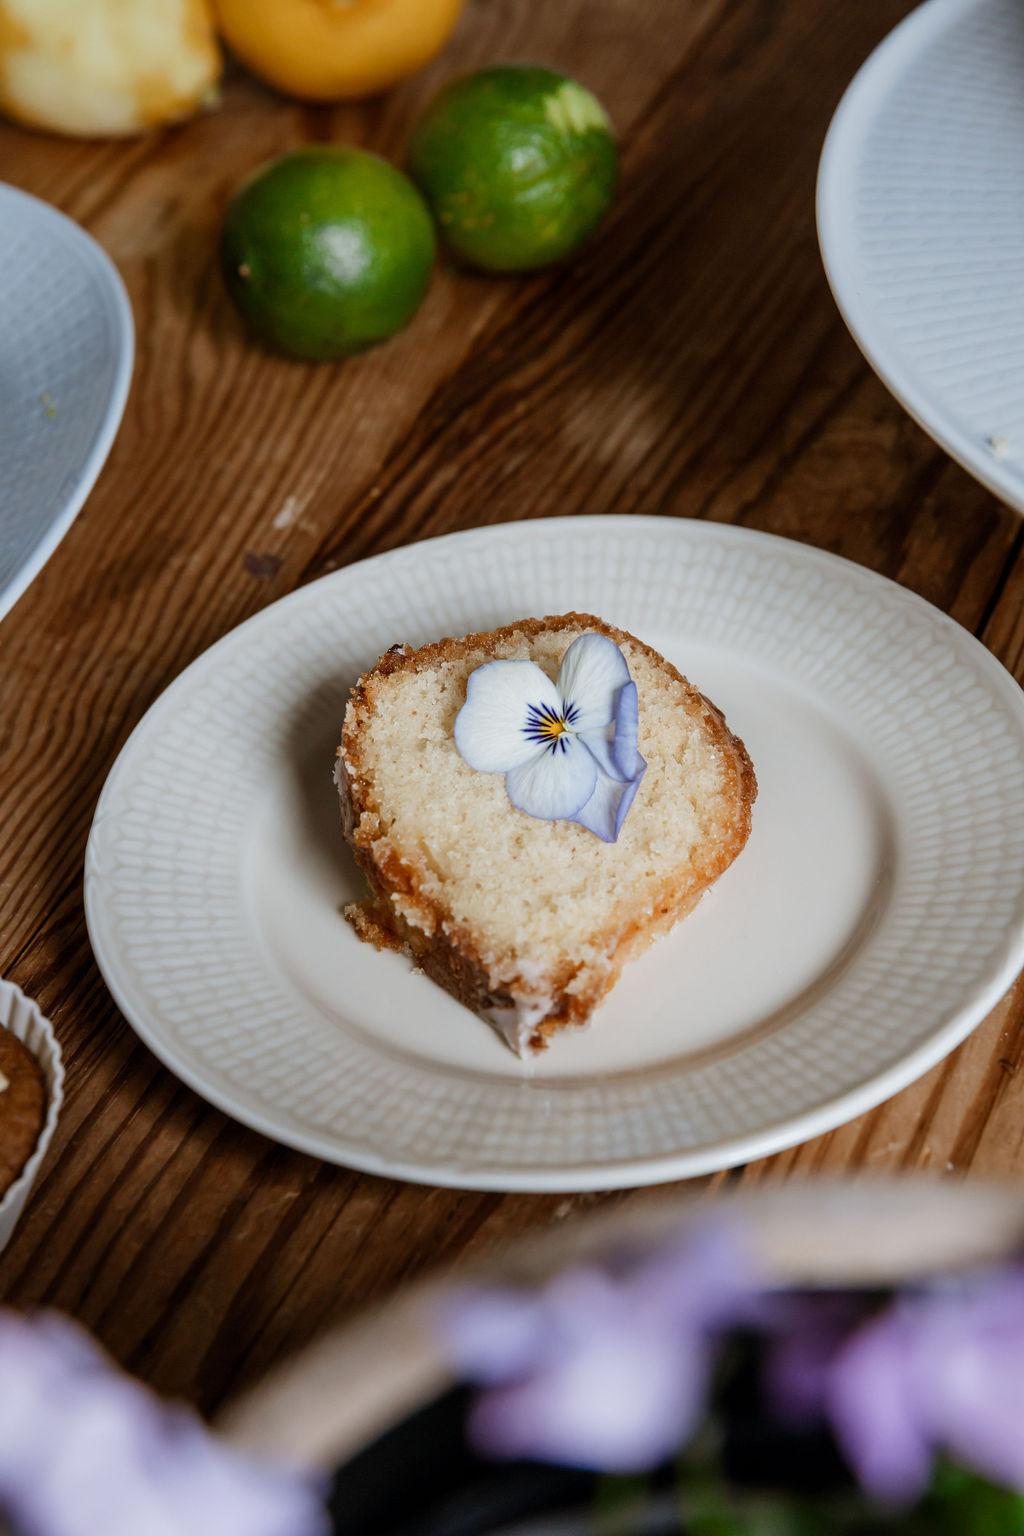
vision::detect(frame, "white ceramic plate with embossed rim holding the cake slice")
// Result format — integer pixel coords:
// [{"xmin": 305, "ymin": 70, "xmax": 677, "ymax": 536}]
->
[{"xmin": 86, "ymin": 518, "xmax": 1024, "ymax": 1189}]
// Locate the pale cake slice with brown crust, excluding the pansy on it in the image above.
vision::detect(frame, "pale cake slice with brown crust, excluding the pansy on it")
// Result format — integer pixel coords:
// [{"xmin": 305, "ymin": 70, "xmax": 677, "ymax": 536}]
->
[{"xmin": 336, "ymin": 613, "xmax": 757, "ymax": 1055}]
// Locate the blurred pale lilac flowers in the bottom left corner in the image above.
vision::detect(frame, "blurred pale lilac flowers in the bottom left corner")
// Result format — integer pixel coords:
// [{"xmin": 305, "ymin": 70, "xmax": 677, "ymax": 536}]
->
[{"xmin": 0, "ymin": 1310, "xmax": 327, "ymax": 1536}]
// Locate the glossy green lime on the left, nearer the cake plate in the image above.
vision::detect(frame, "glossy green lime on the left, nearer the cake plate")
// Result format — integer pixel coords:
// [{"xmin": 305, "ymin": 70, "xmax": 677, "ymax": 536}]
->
[{"xmin": 221, "ymin": 146, "xmax": 434, "ymax": 362}]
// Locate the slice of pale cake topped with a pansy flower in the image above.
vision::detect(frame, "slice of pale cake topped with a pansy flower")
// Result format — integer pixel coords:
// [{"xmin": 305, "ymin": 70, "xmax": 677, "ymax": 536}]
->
[{"xmin": 336, "ymin": 613, "xmax": 757, "ymax": 1055}]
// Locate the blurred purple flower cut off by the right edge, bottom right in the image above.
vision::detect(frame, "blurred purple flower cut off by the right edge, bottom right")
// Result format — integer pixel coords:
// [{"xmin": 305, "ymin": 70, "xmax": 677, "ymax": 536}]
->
[{"xmin": 768, "ymin": 1270, "xmax": 1024, "ymax": 1504}]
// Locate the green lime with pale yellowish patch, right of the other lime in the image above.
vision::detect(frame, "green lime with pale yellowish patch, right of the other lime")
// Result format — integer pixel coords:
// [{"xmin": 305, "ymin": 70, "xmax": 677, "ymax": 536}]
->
[{"xmin": 410, "ymin": 65, "xmax": 617, "ymax": 272}]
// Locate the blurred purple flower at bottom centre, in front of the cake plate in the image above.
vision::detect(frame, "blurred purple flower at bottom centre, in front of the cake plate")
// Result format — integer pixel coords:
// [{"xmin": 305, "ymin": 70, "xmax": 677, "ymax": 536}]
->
[{"xmin": 442, "ymin": 1227, "xmax": 758, "ymax": 1473}]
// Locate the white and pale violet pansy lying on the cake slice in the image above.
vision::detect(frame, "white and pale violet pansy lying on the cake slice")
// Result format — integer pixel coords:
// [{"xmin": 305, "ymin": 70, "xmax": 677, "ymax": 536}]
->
[{"xmin": 454, "ymin": 633, "xmax": 646, "ymax": 843}]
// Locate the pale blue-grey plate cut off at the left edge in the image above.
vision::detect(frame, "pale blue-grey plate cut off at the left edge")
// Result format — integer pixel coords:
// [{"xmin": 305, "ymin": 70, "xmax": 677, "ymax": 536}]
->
[{"xmin": 0, "ymin": 184, "xmax": 134, "ymax": 619}]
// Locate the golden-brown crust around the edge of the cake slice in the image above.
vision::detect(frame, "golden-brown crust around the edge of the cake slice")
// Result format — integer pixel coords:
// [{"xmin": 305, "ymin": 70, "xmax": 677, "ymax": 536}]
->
[{"xmin": 338, "ymin": 613, "xmax": 757, "ymax": 1051}]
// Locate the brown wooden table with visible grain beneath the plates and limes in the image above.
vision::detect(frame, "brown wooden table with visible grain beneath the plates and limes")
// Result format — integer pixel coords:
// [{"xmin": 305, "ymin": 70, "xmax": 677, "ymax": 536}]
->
[{"xmin": 0, "ymin": 0, "xmax": 1024, "ymax": 1409}]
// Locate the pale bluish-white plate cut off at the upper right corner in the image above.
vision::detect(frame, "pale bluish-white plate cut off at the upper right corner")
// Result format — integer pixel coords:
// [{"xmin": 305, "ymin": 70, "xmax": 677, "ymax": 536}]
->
[{"xmin": 818, "ymin": 0, "xmax": 1024, "ymax": 510}]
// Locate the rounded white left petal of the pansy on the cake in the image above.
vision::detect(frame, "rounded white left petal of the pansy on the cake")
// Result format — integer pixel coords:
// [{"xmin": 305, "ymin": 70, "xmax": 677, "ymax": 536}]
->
[{"xmin": 454, "ymin": 660, "xmax": 562, "ymax": 773}]
